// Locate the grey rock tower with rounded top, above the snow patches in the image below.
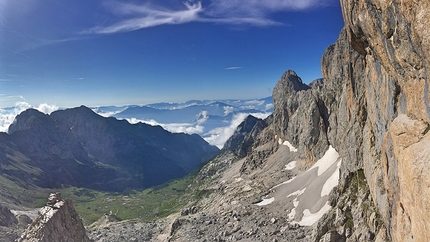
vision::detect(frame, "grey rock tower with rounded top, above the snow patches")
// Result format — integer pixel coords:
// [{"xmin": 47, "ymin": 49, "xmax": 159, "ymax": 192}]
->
[{"xmin": 272, "ymin": 70, "xmax": 328, "ymax": 161}]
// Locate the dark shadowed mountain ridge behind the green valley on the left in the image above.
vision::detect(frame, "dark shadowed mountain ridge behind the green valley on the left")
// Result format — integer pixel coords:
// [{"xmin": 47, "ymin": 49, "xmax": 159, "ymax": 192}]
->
[{"xmin": 0, "ymin": 106, "xmax": 219, "ymax": 191}]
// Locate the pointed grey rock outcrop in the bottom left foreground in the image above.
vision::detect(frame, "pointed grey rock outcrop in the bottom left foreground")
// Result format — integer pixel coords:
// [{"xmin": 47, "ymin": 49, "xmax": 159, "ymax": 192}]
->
[{"xmin": 17, "ymin": 193, "xmax": 90, "ymax": 242}]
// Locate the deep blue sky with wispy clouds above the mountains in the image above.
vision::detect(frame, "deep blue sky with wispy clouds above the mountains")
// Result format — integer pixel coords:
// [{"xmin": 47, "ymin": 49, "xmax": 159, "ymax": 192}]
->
[{"xmin": 0, "ymin": 0, "xmax": 343, "ymax": 107}]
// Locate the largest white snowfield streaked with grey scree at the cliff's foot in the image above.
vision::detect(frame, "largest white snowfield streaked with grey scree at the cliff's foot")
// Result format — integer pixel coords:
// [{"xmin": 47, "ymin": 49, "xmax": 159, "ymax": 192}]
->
[{"xmin": 256, "ymin": 146, "xmax": 342, "ymax": 226}]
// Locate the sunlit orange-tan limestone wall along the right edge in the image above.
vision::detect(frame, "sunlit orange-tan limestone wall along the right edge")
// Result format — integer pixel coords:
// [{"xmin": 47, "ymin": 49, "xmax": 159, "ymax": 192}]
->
[{"xmin": 338, "ymin": 0, "xmax": 430, "ymax": 241}]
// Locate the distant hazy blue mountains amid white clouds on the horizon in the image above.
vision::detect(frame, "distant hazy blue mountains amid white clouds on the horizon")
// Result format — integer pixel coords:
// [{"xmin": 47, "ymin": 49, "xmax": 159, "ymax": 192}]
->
[{"xmin": 92, "ymin": 97, "xmax": 273, "ymax": 148}]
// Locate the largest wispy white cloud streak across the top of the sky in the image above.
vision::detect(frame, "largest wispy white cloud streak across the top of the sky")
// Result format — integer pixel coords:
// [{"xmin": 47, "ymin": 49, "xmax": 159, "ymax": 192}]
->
[{"xmin": 81, "ymin": 0, "xmax": 333, "ymax": 34}]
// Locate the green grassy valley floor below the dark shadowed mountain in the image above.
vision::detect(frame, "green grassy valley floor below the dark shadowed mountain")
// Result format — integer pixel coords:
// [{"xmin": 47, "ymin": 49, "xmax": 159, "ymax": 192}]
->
[{"xmin": 47, "ymin": 172, "xmax": 195, "ymax": 225}]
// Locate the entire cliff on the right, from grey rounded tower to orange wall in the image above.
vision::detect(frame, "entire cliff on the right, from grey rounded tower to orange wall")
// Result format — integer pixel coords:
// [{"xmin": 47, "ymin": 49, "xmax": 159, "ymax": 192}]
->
[{"xmin": 247, "ymin": 0, "xmax": 430, "ymax": 241}]
